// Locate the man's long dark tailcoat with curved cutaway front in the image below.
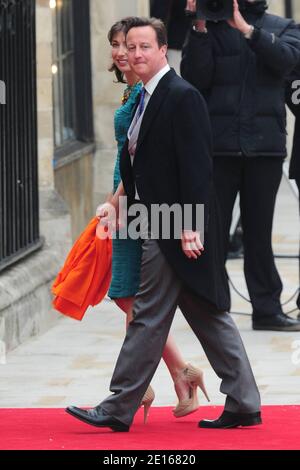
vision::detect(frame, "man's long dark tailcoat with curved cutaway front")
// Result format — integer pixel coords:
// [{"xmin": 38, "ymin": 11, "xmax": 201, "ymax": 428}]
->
[{"xmin": 120, "ymin": 70, "xmax": 229, "ymax": 310}]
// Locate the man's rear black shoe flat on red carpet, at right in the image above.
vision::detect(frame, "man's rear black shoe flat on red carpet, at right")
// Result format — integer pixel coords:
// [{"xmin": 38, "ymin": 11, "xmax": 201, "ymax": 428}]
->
[{"xmin": 198, "ymin": 411, "xmax": 262, "ymax": 429}]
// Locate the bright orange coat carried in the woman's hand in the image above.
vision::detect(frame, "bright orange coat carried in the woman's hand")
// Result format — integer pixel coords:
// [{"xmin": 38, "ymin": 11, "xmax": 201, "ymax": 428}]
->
[{"xmin": 52, "ymin": 217, "xmax": 112, "ymax": 320}]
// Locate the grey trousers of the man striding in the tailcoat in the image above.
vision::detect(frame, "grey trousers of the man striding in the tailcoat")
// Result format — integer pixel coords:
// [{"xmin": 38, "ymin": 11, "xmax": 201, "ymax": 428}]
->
[{"xmin": 99, "ymin": 240, "xmax": 260, "ymax": 425}]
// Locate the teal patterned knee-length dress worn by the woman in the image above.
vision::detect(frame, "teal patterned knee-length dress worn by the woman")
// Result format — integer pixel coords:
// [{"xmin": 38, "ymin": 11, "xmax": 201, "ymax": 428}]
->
[{"xmin": 108, "ymin": 83, "xmax": 142, "ymax": 299}]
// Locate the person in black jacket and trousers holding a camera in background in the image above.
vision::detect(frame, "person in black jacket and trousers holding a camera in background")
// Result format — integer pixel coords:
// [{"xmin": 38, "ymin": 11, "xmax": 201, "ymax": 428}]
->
[{"xmin": 181, "ymin": 0, "xmax": 300, "ymax": 331}]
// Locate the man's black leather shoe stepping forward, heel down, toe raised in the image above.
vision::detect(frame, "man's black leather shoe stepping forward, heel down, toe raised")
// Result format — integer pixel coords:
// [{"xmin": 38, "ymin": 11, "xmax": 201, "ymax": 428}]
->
[{"xmin": 65, "ymin": 406, "xmax": 129, "ymax": 432}]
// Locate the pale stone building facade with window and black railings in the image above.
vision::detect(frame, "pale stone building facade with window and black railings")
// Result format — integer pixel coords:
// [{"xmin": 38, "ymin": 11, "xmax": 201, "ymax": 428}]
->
[{"xmin": 0, "ymin": 0, "xmax": 149, "ymax": 351}]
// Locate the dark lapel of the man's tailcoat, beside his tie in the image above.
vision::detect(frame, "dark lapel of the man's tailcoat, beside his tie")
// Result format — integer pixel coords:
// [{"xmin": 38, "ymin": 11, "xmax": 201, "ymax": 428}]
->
[{"xmin": 134, "ymin": 69, "xmax": 176, "ymax": 157}]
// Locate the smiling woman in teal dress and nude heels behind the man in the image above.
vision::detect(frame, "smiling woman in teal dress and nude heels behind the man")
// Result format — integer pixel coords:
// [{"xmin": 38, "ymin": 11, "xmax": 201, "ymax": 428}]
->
[{"xmin": 97, "ymin": 19, "xmax": 207, "ymax": 420}]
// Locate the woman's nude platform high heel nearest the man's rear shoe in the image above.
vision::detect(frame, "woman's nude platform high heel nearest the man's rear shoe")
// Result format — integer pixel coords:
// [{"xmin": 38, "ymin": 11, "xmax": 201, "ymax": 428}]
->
[{"xmin": 173, "ymin": 364, "xmax": 210, "ymax": 418}]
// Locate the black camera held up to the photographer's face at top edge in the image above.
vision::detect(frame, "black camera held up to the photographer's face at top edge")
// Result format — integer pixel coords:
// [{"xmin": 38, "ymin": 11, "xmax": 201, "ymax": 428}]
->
[{"xmin": 196, "ymin": 0, "xmax": 233, "ymax": 21}]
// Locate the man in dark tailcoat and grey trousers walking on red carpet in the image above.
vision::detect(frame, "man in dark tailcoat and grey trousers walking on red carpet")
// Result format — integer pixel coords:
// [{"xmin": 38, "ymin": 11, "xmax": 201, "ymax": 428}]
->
[{"xmin": 67, "ymin": 18, "xmax": 261, "ymax": 431}]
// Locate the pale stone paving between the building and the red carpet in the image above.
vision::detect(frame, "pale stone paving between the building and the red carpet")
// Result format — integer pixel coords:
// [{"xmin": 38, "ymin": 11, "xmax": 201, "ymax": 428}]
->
[{"xmin": 0, "ymin": 176, "xmax": 300, "ymax": 408}]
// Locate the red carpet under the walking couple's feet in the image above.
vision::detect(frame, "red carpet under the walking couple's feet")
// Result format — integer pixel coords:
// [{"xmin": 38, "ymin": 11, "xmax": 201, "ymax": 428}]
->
[{"xmin": 0, "ymin": 406, "xmax": 300, "ymax": 450}]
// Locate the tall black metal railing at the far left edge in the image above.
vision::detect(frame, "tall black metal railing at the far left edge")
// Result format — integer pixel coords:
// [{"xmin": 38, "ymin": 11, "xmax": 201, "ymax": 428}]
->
[{"xmin": 0, "ymin": 0, "xmax": 40, "ymax": 270}]
